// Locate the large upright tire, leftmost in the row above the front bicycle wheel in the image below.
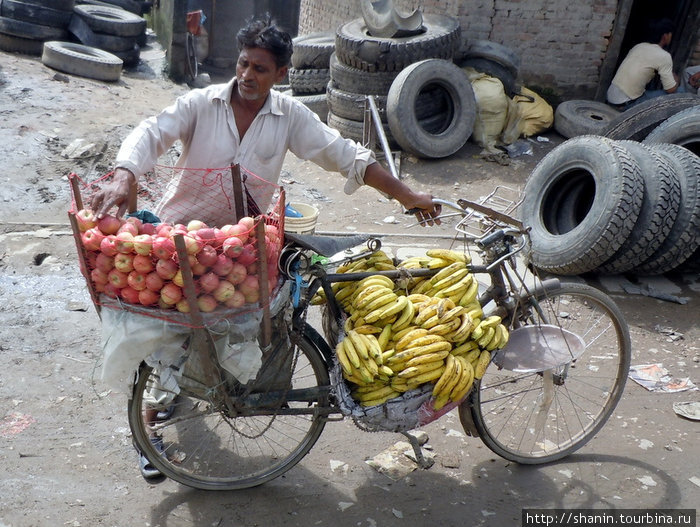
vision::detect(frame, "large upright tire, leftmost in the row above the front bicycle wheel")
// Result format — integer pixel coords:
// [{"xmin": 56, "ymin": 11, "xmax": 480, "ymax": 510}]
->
[{"xmin": 520, "ymin": 136, "xmax": 644, "ymax": 275}]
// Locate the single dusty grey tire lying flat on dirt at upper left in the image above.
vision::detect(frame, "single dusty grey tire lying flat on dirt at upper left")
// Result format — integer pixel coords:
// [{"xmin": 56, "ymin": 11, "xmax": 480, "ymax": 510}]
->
[{"xmin": 41, "ymin": 41, "xmax": 123, "ymax": 82}]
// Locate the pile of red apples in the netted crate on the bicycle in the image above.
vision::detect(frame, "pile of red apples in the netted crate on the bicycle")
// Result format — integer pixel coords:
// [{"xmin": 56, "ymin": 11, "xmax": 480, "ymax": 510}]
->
[{"xmin": 75, "ymin": 209, "xmax": 282, "ymax": 313}]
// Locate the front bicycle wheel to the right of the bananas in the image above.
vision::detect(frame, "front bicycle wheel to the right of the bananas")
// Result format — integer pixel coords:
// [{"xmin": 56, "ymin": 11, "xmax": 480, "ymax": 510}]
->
[{"xmin": 459, "ymin": 284, "xmax": 631, "ymax": 464}]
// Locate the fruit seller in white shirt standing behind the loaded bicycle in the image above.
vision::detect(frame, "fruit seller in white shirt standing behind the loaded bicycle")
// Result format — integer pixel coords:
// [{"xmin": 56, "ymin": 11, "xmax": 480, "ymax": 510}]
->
[{"xmin": 91, "ymin": 16, "xmax": 440, "ymax": 479}]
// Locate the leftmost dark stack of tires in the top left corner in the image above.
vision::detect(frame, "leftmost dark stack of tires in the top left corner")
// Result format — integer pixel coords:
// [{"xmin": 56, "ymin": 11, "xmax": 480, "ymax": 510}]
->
[{"xmin": 0, "ymin": 0, "xmax": 75, "ymax": 55}]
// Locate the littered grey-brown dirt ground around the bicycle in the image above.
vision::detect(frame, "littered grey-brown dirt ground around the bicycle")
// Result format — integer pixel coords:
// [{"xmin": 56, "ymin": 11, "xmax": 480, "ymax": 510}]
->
[{"xmin": 0, "ymin": 44, "xmax": 700, "ymax": 527}]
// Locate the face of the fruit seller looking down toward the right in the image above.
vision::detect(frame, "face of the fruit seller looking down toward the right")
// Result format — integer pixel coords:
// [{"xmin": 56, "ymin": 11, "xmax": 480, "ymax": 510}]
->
[{"xmin": 236, "ymin": 48, "xmax": 287, "ymax": 101}]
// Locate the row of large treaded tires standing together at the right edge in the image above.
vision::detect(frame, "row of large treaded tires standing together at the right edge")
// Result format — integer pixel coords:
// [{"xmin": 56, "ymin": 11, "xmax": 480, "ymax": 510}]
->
[{"xmin": 521, "ymin": 105, "xmax": 700, "ymax": 275}]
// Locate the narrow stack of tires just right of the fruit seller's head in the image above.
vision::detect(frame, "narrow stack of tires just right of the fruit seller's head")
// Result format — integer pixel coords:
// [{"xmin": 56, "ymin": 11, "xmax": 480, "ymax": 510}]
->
[{"xmin": 289, "ymin": 31, "xmax": 335, "ymax": 123}]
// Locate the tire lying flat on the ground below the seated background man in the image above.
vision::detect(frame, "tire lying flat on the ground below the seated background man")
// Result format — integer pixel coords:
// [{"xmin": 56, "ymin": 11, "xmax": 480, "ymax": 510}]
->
[{"xmin": 554, "ymin": 99, "xmax": 620, "ymax": 139}]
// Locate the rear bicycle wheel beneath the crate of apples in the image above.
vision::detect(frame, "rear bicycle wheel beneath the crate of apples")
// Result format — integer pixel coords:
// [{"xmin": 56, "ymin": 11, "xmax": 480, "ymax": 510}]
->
[{"xmin": 129, "ymin": 326, "xmax": 330, "ymax": 490}]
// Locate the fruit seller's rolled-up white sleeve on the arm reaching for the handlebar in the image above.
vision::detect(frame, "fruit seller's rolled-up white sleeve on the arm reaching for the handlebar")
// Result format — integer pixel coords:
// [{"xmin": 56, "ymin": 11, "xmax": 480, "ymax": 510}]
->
[{"xmin": 289, "ymin": 101, "xmax": 375, "ymax": 194}]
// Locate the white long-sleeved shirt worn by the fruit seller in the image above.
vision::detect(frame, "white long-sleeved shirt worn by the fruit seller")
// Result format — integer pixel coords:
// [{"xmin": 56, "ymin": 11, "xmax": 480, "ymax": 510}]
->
[{"xmin": 116, "ymin": 78, "xmax": 375, "ymax": 226}]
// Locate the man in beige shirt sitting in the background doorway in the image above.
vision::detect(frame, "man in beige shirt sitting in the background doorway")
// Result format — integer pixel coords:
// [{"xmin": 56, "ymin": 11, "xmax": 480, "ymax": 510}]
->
[{"xmin": 607, "ymin": 19, "xmax": 678, "ymax": 110}]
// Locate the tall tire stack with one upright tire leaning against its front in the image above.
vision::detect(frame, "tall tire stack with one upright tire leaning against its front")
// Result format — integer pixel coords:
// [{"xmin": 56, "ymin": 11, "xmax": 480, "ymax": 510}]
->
[{"xmin": 327, "ymin": 14, "xmax": 476, "ymax": 158}]
